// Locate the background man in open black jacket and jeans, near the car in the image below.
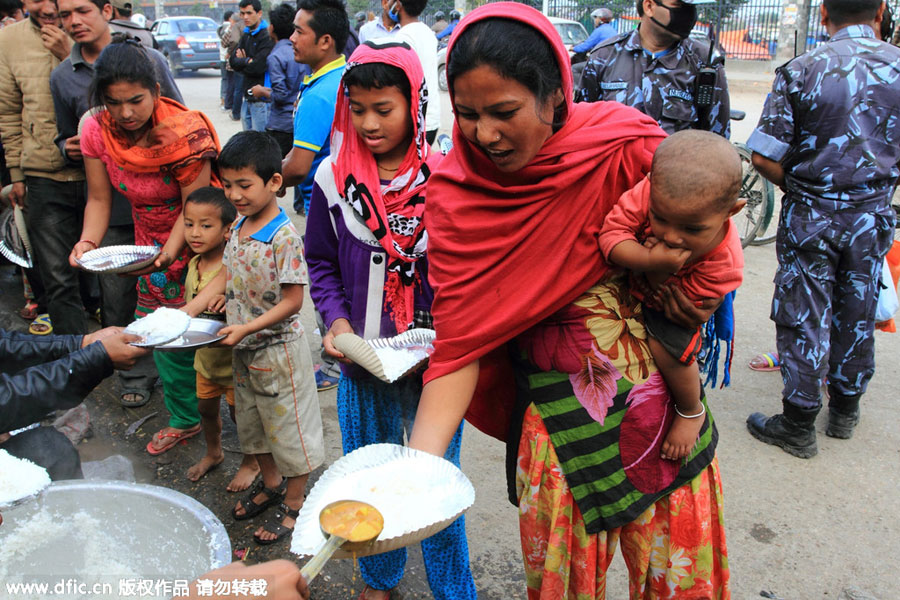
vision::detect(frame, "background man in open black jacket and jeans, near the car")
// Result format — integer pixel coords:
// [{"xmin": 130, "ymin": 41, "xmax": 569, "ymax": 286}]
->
[{"xmin": 229, "ymin": 0, "xmax": 275, "ymax": 131}]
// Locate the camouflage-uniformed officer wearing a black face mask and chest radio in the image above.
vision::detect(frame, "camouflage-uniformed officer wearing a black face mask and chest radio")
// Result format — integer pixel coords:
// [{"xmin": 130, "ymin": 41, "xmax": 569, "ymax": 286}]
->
[{"xmin": 578, "ymin": 0, "xmax": 731, "ymax": 137}]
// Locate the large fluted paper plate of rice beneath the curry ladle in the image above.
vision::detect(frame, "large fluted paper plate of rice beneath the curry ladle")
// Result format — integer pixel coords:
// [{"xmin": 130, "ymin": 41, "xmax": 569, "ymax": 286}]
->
[{"xmin": 291, "ymin": 444, "xmax": 475, "ymax": 558}]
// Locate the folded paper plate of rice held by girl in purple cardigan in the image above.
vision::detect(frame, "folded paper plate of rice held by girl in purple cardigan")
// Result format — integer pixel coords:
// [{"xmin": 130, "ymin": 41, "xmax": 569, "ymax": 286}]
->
[{"xmin": 334, "ymin": 329, "xmax": 436, "ymax": 383}]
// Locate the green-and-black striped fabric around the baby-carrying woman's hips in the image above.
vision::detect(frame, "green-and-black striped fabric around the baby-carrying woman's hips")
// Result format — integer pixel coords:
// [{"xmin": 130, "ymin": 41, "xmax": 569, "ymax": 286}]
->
[{"xmin": 515, "ymin": 360, "xmax": 718, "ymax": 533}]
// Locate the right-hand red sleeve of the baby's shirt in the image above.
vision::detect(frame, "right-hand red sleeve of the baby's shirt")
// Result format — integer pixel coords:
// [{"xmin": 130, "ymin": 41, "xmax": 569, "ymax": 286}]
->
[{"xmin": 679, "ymin": 219, "xmax": 744, "ymax": 300}]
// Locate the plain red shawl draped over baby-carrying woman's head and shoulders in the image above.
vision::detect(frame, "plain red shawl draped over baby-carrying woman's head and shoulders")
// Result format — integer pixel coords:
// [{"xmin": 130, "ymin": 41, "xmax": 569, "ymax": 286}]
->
[{"xmin": 425, "ymin": 2, "xmax": 665, "ymax": 438}]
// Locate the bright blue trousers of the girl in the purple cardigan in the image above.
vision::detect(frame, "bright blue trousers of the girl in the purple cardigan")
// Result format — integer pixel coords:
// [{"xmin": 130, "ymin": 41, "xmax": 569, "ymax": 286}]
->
[{"xmin": 337, "ymin": 375, "xmax": 476, "ymax": 600}]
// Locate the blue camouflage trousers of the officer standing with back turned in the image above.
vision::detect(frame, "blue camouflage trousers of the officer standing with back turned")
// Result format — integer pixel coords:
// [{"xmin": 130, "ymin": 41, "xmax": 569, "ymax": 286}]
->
[{"xmin": 771, "ymin": 196, "xmax": 894, "ymax": 409}]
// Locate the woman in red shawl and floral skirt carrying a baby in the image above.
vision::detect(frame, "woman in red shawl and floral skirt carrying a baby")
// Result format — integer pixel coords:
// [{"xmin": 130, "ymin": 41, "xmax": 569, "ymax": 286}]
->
[{"xmin": 410, "ymin": 3, "xmax": 730, "ymax": 600}]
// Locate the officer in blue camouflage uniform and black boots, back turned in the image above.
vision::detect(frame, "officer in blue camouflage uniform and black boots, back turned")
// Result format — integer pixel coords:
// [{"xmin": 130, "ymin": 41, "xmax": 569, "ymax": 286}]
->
[{"xmin": 747, "ymin": 0, "xmax": 900, "ymax": 458}]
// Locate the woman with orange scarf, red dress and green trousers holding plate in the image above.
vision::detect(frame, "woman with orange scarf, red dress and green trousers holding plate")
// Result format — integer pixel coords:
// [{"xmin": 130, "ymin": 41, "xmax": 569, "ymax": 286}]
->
[{"xmin": 69, "ymin": 40, "xmax": 219, "ymax": 454}]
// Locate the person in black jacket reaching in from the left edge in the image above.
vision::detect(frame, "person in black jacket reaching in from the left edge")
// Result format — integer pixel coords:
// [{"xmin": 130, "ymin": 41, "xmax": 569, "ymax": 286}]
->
[{"xmin": 0, "ymin": 327, "xmax": 149, "ymax": 480}]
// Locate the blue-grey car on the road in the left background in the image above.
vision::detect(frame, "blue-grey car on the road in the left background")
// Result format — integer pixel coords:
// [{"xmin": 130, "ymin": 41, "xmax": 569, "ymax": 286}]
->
[{"xmin": 150, "ymin": 17, "xmax": 221, "ymax": 75}]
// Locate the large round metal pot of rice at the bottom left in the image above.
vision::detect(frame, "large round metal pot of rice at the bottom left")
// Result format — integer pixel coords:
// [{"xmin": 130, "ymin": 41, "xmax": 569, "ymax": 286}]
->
[{"xmin": 0, "ymin": 480, "xmax": 231, "ymax": 600}]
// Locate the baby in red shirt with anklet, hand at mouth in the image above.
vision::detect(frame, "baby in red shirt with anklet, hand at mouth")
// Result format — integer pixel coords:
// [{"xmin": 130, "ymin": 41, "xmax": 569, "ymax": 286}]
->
[{"xmin": 599, "ymin": 130, "xmax": 745, "ymax": 460}]
